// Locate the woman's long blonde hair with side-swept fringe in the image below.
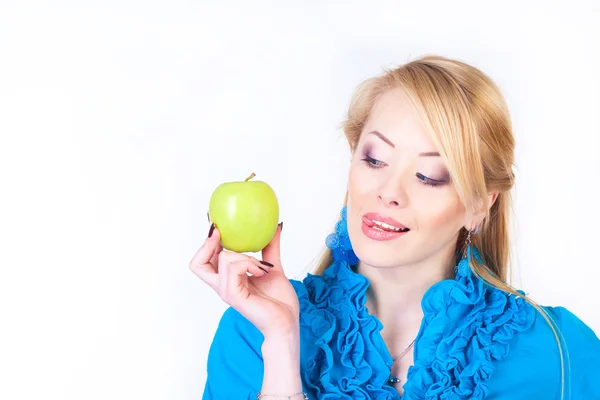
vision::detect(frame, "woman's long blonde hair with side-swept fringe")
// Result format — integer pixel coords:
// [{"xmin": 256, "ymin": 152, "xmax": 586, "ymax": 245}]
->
[{"xmin": 315, "ymin": 55, "xmax": 568, "ymax": 398}]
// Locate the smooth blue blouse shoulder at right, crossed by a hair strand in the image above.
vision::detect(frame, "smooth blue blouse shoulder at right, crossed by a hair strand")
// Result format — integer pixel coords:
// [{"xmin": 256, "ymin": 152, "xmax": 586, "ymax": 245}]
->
[{"xmin": 489, "ymin": 305, "xmax": 600, "ymax": 400}]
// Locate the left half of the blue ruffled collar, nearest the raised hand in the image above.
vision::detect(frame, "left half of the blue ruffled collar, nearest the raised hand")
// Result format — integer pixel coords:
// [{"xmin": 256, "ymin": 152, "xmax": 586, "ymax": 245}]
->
[{"xmin": 296, "ymin": 261, "xmax": 397, "ymax": 400}]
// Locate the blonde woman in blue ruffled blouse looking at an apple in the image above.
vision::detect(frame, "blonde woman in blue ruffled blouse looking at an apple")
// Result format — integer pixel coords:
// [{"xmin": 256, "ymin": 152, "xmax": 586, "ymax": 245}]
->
[{"xmin": 190, "ymin": 56, "xmax": 600, "ymax": 400}]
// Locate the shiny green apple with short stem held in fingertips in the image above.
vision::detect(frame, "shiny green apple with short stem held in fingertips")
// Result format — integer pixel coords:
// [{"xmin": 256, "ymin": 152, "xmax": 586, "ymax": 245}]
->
[{"xmin": 208, "ymin": 173, "xmax": 279, "ymax": 253}]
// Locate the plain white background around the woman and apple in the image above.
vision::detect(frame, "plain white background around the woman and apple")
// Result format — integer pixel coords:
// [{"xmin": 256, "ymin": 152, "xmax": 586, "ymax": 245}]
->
[{"xmin": 0, "ymin": 0, "xmax": 600, "ymax": 399}]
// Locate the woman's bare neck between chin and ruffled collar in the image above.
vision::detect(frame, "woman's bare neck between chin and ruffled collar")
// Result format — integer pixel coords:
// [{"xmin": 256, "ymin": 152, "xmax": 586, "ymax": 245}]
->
[{"xmin": 357, "ymin": 245, "xmax": 455, "ymax": 326}]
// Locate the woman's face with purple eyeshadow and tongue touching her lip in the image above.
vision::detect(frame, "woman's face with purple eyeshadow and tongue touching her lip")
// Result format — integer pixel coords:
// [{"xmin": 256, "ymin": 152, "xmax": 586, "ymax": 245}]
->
[{"xmin": 348, "ymin": 89, "xmax": 467, "ymax": 267}]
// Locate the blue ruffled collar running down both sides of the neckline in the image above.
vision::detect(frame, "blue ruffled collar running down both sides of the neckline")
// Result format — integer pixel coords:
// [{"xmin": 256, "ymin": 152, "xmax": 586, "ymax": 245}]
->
[{"xmin": 294, "ymin": 253, "xmax": 535, "ymax": 400}]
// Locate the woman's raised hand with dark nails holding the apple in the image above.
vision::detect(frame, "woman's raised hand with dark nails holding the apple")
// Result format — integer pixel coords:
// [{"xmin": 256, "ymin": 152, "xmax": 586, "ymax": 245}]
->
[{"xmin": 189, "ymin": 224, "xmax": 299, "ymax": 338}]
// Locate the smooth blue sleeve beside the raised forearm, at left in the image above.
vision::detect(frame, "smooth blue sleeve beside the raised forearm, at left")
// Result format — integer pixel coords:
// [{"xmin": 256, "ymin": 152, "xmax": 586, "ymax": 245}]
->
[{"xmin": 202, "ymin": 307, "xmax": 264, "ymax": 400}]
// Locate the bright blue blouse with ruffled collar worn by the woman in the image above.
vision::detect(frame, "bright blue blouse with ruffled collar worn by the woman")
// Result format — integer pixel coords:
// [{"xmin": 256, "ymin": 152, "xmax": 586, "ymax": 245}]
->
[{"xmin": 203, "ymin": 255, "xmax": 600, "ymax": 400}]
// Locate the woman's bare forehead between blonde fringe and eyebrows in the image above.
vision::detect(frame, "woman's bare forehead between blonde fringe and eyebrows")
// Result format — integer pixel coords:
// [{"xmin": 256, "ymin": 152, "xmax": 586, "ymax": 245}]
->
[{"xmin": 363, "ymin": 88, "xmax": 435, "ymax": 151}]
